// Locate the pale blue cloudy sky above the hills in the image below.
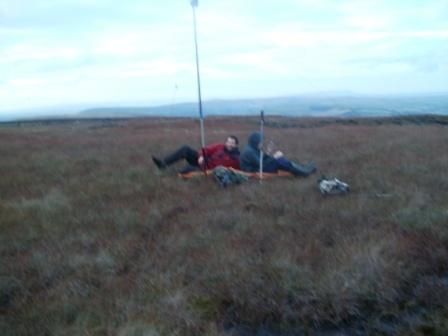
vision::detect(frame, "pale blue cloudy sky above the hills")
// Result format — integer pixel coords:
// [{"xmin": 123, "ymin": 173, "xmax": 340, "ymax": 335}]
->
[{"xmin": 0, "ymin": 0, "xmax": 448, "ymax": 116}]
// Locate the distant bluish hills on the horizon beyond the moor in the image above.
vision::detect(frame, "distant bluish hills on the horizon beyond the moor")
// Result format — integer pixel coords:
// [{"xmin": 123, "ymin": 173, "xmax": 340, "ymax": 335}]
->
[{"xmin": 77, "ymin": 94, "xmax": 448, "ymax": 118}]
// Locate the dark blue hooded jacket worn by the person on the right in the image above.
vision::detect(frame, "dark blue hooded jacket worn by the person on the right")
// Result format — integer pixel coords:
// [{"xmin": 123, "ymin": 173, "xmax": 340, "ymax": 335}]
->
[{"xmin": 240, "ymin": 132, "xmax": 278, "ymax": 173}]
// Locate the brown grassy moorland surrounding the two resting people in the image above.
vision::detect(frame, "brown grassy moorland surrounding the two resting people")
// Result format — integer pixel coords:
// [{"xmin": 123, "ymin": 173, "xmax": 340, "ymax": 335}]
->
[{"xmin": 0, "ymin": 116, "xmax": 448, "ymax": 336}]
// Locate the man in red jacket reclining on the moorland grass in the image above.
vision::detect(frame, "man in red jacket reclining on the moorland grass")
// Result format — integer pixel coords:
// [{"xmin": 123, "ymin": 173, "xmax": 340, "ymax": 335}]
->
[{"xmin": 152, "ymin": 135, "xmax": 240, "ymax": 173}]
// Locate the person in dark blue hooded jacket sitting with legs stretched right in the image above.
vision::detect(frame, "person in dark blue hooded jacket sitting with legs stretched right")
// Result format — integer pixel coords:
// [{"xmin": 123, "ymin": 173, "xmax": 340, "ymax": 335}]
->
[{"xmin": 240, "ymin": 132, "xmax": 316, "ymax": 176}]
